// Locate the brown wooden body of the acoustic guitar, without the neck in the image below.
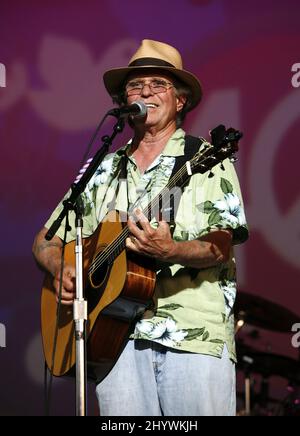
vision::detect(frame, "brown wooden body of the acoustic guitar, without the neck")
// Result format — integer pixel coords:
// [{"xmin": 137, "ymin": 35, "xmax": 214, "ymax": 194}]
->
[{"xmin": 41, "ymin": 211, "xmax": 156, "ymax": 381}]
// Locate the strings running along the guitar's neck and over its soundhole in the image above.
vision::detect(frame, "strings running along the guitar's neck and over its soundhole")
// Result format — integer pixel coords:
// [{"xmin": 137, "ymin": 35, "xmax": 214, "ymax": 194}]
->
[{"xmin": 88, "ymin": 147, "xmax": 223, "ymax": 278}]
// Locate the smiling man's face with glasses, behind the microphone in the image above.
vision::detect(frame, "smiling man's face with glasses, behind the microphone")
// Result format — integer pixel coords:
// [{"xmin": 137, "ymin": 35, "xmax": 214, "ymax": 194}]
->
[{"xmin": 126, "ymin": 72, "xmax": 185, "ymax": 129}]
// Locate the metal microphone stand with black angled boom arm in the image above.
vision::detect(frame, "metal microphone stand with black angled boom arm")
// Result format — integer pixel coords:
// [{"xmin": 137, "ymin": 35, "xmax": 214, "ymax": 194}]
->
[{"xmin": 45, "ymin": 112, "xmax": 125, "ymax": 416}]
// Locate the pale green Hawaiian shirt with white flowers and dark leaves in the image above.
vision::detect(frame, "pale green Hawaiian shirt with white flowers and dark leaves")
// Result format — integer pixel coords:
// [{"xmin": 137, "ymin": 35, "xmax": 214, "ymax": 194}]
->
[{"xmin": 46, "ymin": 129, "xmax": 248, "ymax": 361}]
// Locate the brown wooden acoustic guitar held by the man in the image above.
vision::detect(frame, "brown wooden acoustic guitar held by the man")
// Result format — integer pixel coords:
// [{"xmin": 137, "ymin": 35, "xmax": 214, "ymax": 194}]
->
[{"xmin": 41, "ymin": 128, "xmax": 241, "ymax": 381}]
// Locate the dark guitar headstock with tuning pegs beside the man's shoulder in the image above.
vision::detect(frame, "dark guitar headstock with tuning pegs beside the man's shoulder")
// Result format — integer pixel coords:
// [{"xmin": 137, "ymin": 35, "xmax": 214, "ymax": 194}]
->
[{"xmin": 191, "ymin": 124, "xmax": 243, "ymax": 174}]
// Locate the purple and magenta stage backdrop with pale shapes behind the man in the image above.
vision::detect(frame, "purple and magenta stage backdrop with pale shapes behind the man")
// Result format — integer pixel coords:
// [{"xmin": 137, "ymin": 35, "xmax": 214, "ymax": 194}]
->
[{"xmin": 0, "ymin": 0, "xmax": 300, "ymax": 415}]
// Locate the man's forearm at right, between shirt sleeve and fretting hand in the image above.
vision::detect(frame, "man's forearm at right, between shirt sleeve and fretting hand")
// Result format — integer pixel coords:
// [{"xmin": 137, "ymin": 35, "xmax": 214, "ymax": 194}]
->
[{"xmin": 168, "ymin": 239, "xmax": 228, "ymax": 269}]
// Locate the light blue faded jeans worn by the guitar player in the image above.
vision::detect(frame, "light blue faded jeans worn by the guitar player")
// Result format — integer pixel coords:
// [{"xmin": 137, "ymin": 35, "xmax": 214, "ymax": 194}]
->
[{"xmin": 96, "ymin": 340, "xmax": 236, "ymax": 416}]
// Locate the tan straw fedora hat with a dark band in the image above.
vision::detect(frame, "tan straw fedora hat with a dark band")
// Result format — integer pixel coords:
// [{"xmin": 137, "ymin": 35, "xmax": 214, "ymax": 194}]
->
[{"xmin": 103, "ymin": 39, "xmax": 202, "ymax": 110}]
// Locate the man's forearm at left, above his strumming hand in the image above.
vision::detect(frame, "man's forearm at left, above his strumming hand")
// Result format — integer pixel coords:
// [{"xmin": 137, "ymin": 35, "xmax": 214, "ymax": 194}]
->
[{"xmin": 32, "ymin": 228, "xmax": 62, "ymax": 275}]
